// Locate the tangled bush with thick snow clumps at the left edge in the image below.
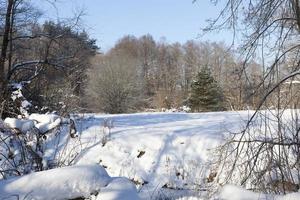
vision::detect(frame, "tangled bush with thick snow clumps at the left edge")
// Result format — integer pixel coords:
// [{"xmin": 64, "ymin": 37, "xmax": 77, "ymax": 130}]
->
[{"xmin": 0, "ymin": 114, "xmax": 78, "ymax": 179}]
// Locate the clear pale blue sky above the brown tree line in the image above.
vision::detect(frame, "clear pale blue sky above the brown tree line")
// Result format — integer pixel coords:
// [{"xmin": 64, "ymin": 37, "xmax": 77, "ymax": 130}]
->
[{"xmin": 38, "ymin": 0, "xmax": 231, "ymax": 50}]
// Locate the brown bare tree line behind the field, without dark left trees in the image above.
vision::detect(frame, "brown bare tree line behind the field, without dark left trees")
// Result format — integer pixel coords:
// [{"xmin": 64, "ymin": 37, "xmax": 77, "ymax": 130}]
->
[{"xmin": 85, "ymin": 34, "xmax": 262, "ymax": 113}]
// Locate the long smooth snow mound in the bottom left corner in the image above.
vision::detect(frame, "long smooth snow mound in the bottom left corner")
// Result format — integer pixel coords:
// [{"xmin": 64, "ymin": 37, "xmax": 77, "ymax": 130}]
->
[{"xmin": 0, "ymin": 165, "xmax": 111, "ymax": 200}]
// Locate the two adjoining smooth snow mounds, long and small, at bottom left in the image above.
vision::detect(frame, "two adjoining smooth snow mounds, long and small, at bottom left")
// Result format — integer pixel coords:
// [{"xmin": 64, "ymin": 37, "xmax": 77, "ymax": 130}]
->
[{"xmin": 0, "ymin": 164, "xmax": 138, "ymax": 200}]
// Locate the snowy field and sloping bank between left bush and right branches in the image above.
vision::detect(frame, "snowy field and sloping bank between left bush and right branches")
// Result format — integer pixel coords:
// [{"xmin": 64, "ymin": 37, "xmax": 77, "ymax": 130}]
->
[{"xmin": 76, "ymin": 111, "xmax": 250, "ymax": 199}]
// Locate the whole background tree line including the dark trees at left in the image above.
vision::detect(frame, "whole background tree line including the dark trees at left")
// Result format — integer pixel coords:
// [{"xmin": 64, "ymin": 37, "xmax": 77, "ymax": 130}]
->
[{"xmin": 0, "ymin": 0, "xmax": 284, "ymax": 117}]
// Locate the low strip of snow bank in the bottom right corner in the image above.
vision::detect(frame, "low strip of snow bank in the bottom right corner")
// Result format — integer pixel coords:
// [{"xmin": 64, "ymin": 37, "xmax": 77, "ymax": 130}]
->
[{"xmin": 219, "ymin": 185, "xmax": 300, "ymax": 200}]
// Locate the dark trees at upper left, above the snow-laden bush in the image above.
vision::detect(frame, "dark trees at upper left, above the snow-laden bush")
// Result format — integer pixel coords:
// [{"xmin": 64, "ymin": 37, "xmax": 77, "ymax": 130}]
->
[{"xmin": 0, "ymin": 0, "xmax": 97, "ymax": 117}]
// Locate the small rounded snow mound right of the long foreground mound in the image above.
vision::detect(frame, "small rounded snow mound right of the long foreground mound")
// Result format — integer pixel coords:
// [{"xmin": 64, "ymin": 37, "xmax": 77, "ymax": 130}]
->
[{"xmin": 97, "ymin": 177, "xmax": 140, "ymax": 200}]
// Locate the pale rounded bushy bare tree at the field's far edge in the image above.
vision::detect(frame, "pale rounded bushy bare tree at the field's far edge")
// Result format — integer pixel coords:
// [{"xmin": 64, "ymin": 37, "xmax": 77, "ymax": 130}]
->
[{"xmin": 86, "ymin": 52, "xmax": 141, "ymax": 113}]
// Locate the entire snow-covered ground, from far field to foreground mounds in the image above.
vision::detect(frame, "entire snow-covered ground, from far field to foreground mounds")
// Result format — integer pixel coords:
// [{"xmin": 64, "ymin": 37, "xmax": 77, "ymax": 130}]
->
[{"xmin": 0, "ymin": 111, "xmax": 299, "ymax": 200}]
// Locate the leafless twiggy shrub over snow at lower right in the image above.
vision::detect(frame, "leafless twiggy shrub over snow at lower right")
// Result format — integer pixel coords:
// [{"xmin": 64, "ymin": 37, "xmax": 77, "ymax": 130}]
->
[{"xmin": 210, "ymin": 110, "xmax": 300, "ymax": 193}]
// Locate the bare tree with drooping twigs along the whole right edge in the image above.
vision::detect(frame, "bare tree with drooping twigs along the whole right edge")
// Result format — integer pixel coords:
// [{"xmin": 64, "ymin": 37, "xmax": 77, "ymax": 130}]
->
[{"xmin": 200, "ymin": 0, "xmax": 300, "ymax": 193}]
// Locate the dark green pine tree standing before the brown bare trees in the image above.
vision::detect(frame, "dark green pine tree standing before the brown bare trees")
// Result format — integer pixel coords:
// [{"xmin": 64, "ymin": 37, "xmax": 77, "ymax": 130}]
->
[{"xmin": 189, "ymin": 67, "xmax": 224, "ymax": 112}]
